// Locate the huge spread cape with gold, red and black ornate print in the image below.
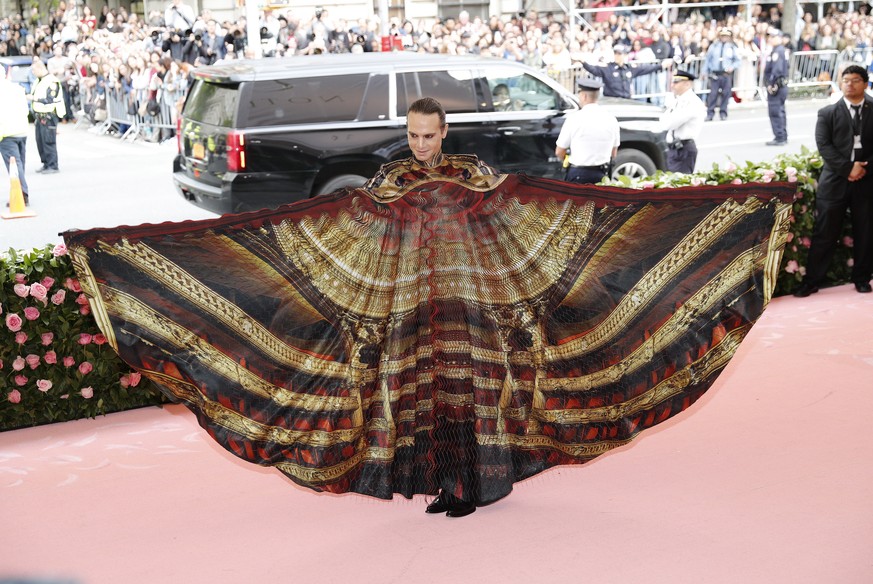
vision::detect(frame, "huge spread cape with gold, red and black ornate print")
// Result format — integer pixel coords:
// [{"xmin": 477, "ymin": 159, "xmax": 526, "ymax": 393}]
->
[{"xmin": 65, "ymin": 156, "xmax": 793, "ymax": 503}]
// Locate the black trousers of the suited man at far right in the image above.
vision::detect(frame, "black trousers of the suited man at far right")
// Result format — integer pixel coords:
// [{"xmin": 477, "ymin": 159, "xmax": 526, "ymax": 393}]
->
[{"xmin": 803, "ymin": 179, "xmax": 873, "ymax": 286}]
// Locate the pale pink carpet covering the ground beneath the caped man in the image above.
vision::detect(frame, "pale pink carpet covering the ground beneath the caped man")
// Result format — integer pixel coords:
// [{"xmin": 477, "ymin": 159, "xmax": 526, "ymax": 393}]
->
[{"xmin": 0, "ymin": 286, "xmax": 873, "ymax": 584}]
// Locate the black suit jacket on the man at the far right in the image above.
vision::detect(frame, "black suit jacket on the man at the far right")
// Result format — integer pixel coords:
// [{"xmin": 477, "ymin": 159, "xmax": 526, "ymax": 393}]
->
[{"xmin": 815, "ymin": 95, "xmax": 873, "ymax": 199}]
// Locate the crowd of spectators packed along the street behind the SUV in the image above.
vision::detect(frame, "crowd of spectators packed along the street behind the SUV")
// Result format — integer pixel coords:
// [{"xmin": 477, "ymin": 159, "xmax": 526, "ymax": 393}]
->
[{"xmin": 0, "ymin": 0, "xmax": 873, "ymax": 139}]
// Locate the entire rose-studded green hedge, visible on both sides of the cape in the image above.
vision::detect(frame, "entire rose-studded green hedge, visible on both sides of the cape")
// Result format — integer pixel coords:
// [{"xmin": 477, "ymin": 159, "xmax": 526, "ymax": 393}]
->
[{"xmin": 0, "ymin": 149, "xmax": 852, "ymax": 430}]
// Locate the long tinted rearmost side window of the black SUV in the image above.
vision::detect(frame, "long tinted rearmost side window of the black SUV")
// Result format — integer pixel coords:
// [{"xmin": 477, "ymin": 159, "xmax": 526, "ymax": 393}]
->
[{"xmin": 240, "ymin": 73, "xmax": 370, "ymax": 126}]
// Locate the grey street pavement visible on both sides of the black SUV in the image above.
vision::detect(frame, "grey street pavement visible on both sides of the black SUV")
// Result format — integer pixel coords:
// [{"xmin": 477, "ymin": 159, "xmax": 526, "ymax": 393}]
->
[{"xmin": 0, "ymin": 100, "xmax": 826, "ymax": 253}]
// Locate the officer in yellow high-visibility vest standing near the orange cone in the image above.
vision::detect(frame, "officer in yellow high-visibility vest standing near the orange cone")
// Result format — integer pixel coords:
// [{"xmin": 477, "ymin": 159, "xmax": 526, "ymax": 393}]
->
[{"xmin": 28, "ymin": 58, "xmax": 67, "ymax": 173}]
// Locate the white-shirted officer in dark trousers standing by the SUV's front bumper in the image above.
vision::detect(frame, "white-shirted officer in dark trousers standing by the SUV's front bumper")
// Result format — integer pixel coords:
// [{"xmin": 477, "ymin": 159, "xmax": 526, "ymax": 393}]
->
[{"xmin": 661, "ymin": 71, "xmax": 706, "ymax": 174}]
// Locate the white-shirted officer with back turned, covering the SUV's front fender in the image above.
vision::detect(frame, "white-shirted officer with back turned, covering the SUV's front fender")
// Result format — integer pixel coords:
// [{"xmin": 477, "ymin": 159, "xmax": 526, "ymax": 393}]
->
[{"xmin": 555, "ymin": 79, "xmax": 620, "ymax": 184}]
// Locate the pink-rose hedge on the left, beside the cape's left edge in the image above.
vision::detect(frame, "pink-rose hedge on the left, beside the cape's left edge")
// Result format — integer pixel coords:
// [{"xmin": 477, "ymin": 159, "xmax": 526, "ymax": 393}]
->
[{"xmin": 0, "ymin": 245, "xmax": 163, "ymax": 430}]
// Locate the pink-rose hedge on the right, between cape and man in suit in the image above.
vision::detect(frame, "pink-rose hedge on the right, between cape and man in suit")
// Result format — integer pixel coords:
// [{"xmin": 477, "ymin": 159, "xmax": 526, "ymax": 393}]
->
[{"xmin": 601, "ymin": 147, "xmax": 852, "ymax": 296}]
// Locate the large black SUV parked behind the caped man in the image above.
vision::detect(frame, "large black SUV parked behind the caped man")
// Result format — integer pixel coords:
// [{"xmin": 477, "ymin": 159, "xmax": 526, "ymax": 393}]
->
[{"xmin": 173, "ymin": 53, "xmax": 667, "ymax": 213}]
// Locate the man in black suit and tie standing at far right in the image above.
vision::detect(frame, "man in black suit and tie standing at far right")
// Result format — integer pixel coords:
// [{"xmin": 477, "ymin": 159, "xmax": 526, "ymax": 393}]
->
[{"xmin": 794, "ymin": 65, "xmax": 873, "ymax": 298}]
